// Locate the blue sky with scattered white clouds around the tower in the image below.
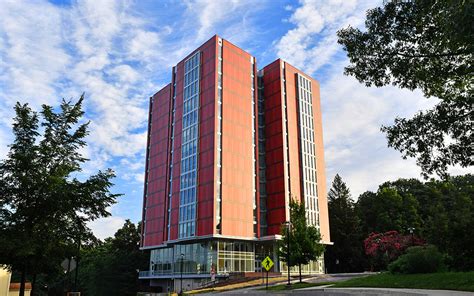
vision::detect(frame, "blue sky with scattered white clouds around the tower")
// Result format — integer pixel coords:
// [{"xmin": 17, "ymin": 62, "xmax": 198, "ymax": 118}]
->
[{"xmin": 0, "ymin": 0, "xmax": 462, "ymax": 238}]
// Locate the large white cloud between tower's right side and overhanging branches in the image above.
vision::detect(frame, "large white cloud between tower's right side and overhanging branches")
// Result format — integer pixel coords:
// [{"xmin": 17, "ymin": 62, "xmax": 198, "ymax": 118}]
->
[{"xmin": 321, "ymin": 62, "xmax": 435, "ymax": 198}]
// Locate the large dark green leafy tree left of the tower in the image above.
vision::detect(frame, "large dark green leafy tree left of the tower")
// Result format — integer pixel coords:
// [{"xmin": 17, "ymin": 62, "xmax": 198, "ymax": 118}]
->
[{"xmin": 0, "ymin": 96, "xmax": 118, "ymax": 295}]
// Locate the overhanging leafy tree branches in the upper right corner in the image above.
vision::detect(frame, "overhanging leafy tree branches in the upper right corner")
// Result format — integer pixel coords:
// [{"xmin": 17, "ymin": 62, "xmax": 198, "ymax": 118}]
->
[{"xmin": 338, "ymin": 0, "xmax": 474, "ymax": 177}]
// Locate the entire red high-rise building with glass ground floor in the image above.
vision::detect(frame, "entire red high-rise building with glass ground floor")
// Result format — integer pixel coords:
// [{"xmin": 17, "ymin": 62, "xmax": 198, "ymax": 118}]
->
[{"xmin": 140, "ymin": 36, "xmax": 329, "ymax": 291}]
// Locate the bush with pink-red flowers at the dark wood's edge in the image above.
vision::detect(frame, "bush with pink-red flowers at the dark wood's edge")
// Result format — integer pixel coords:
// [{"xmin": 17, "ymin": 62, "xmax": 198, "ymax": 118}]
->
[{"xmin": 364, "ymin": 230, "xmax": 425, "ymax": 270}]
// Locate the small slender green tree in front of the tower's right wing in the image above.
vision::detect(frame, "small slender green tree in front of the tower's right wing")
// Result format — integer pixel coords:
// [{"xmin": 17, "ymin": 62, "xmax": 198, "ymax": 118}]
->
[{"xmin": 279, "ymin": 199, "xmax": 324, "ymax": 282}]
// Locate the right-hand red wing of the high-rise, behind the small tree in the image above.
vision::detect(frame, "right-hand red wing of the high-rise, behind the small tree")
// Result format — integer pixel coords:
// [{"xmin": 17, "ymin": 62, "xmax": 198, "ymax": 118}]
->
[{"xmin": 258, "ymin": 59, "xmax": 329, "ymax": 243}]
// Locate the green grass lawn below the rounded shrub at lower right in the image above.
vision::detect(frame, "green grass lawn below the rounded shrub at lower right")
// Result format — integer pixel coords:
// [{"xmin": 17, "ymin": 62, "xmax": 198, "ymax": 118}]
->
[{"xmin": 331, "ymin": 272, "xmax": 474, "ymax": 292}]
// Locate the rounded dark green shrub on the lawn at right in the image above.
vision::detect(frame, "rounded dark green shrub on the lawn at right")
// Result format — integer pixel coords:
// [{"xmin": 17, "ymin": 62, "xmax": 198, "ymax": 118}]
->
[{"xmin": 388, "ymin": 245, "xmax": 446, "ymax": 273}]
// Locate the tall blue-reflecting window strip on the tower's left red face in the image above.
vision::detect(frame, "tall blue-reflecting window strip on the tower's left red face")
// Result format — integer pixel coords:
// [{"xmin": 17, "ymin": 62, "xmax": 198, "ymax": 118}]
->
[{"xmin": 178, "ymin": 52, "xmax": 201, "ymax": 238}]
